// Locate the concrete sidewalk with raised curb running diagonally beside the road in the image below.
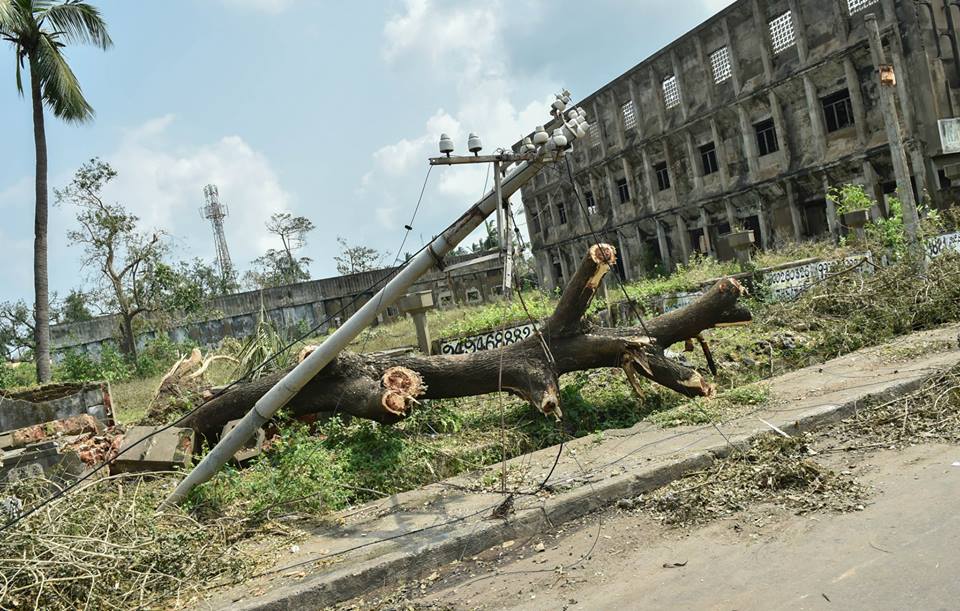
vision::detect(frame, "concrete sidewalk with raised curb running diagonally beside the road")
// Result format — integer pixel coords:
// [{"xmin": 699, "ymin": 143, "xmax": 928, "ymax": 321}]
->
[{"xmin": 201, "ymin": 325, "xmax": 960, "ymax": 610}]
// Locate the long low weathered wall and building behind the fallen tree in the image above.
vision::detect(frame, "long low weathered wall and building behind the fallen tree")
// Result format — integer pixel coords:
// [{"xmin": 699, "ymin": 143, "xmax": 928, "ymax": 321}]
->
[{"xmin": 50, "ymin": 252, "xmax": 503, "ymax": 355}]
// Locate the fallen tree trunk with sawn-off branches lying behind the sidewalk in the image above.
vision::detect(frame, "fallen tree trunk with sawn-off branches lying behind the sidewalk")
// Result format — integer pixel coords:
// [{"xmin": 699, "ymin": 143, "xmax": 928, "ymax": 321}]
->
[{"xmin": 182, "ymin": 244, "xmax": 751, "ymax": 436}]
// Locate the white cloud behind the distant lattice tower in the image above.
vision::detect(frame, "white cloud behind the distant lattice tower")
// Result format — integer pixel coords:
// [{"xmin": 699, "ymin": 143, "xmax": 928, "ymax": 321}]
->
[{"xmin": 98, "ymin": 115, "xmax": 291, "ymax": 269}]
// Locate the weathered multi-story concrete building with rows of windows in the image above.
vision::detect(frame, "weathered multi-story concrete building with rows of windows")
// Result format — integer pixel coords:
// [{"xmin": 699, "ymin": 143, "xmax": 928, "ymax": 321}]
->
[{"xmin": 521, "ymin": 0, "xmax": 960, "ymax": 287}]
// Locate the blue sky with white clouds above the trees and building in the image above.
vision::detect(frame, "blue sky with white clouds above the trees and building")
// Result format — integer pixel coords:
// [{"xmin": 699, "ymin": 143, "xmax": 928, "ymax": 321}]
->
[{"xmin": 0, "ymin": 0, "xmax": 729, "ymax": 301}]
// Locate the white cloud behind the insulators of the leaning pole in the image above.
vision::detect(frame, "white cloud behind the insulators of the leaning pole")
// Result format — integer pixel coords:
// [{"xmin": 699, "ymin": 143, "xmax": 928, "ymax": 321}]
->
[{"xmin": 360, "ymin": 0, "xmax": 560, "ymax": 244}]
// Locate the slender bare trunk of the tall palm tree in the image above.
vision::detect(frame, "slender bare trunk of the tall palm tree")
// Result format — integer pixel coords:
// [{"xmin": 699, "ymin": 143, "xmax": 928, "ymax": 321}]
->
[{"xmin": 30, "ymin": 56, "xmax": 51, "ymax": 383}]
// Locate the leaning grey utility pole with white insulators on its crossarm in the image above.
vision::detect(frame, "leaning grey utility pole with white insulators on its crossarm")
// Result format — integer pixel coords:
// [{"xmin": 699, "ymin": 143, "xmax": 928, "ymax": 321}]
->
[{"xmin": 164, "ymin": 91, "xmax": 586, "ymax": 506}]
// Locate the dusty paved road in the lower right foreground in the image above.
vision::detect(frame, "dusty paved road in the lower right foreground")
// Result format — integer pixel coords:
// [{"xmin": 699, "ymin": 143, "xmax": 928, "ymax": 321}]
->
[{"xmin": 411, "ymin": 445, "xmax": 960, "ymax": 611}]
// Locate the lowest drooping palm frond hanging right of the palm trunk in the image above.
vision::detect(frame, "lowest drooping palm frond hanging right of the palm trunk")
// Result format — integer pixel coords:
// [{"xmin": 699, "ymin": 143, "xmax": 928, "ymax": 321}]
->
[{"xmin": 30, "ymin": 32, "xmax": 93, "ymax": 123}]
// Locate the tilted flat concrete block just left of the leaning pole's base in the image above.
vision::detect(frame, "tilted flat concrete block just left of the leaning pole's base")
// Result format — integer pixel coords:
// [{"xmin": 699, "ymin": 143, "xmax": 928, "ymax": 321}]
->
[{"xmin": 110, "ymin": 426, "xmax": 194, "ymax": 473}]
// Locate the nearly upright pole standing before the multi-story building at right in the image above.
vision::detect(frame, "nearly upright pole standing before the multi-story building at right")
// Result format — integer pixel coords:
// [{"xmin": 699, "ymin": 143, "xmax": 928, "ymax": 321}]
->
[{"xmin": 865, "ymin": 13, "xmax": 920, "ymax": 242}]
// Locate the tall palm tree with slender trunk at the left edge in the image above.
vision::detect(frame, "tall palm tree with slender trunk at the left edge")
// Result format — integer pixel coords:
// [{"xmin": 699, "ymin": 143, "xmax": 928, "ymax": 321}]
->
[{"xmin": 0, "ymin": 0, "xmax": 113, "ymax": 382}]
